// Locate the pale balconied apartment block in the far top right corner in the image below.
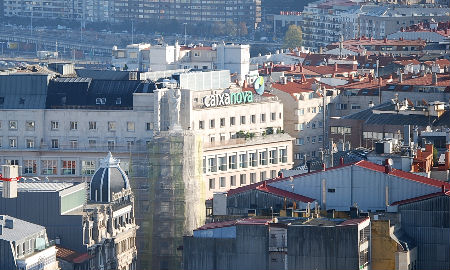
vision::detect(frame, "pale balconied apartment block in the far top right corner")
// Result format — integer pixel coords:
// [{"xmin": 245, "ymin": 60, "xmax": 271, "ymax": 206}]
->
[{"xmin": 300, "ymin": 0, "xmax": 450, "ymax": 51}]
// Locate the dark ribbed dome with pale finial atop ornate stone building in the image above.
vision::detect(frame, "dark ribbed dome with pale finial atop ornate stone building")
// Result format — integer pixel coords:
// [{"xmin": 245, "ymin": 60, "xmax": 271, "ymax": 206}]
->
[{"xmin": 90, "ymin": 152, "xmax": 130, "ymax": 202}]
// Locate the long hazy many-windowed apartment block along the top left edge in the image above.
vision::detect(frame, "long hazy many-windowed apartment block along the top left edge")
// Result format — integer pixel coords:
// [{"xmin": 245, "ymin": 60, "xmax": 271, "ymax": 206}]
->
[{"xmin": 4, "ymin": 0, "xmax": 261, "ymax": 29}]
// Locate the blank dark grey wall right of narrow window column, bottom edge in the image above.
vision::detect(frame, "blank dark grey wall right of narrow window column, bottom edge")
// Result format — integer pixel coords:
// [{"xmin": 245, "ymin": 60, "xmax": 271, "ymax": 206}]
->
[{"xmin": 288, "ymin": 226, "xmax": 359, "ymax": 270}]
